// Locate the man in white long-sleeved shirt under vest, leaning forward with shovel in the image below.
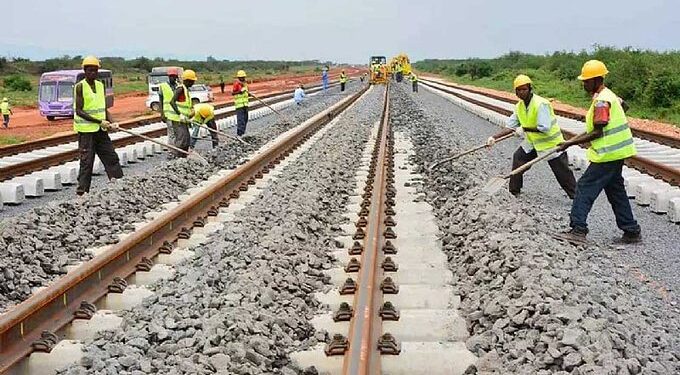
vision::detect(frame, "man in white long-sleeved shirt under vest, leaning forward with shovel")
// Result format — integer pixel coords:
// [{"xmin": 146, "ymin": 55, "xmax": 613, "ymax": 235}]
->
[{"xmin": 487, "ymin": 74, "xmax": 576, "ymax": 199}]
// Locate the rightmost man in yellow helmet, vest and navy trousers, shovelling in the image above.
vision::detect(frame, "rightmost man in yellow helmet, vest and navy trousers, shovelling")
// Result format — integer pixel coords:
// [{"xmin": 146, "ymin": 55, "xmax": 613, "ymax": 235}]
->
[{"xmin": 558, "ymin": 60, "xmax": 642, "ymax": 243}]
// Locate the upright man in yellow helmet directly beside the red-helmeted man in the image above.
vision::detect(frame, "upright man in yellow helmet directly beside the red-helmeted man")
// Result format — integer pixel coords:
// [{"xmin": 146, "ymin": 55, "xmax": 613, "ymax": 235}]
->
[{"xmin": 165, "ymin": 69, "xmax": 198, "ymax": 158}]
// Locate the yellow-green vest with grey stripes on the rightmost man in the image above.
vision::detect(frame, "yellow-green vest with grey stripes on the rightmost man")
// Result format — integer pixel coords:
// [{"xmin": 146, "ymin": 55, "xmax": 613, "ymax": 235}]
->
[{"xmin": 586, "ymin": 87, "xmax": 637, "ymax": 163}]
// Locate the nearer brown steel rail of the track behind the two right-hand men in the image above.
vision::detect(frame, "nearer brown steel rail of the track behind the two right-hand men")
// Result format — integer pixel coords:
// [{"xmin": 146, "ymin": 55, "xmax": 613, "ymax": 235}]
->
[{"xmin": 423, "ymin": 82, "xmax": 680, "ymax": 186}]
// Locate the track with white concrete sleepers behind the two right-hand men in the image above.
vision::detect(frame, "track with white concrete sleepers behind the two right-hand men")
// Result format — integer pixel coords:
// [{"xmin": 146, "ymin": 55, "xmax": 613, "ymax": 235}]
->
[{"xmin": 422, "ymin": 79, "xmax": 680, "ymax": 223}]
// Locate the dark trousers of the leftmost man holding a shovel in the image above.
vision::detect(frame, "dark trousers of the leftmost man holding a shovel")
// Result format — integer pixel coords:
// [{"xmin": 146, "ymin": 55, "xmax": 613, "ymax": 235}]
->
[{"xmin": 76, "ymin": 130, "xmax": 123, "ymax": 195}]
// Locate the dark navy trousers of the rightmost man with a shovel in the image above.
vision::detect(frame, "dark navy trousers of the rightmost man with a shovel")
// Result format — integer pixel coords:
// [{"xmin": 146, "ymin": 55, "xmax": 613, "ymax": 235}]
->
[{"xmin": 569, "ymin": 160, "xmax": 640, "ymax": 233}]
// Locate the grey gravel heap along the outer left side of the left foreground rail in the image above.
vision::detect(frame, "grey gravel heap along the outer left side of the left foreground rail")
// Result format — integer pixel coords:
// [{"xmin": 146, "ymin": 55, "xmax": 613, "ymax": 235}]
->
[{"xmin": 0, "ymin": 84, "xmax": 360, "ymax": 312}]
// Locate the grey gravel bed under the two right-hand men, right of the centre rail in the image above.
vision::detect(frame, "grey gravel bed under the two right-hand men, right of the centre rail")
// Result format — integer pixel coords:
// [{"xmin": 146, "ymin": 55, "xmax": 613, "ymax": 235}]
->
[{"xmin": 391, "ymin": 85, "xmax": 680, "ymax": 374}]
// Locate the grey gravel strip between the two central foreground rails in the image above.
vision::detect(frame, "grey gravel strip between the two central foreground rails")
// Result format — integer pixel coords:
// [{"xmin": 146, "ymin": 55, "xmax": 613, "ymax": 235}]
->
[{"xmin": 59, "ymin": 88, "xmax": 383, "ymax": 374}]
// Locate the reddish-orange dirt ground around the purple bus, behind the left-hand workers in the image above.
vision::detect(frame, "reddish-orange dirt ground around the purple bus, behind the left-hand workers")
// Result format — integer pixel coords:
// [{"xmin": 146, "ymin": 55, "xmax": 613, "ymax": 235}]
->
[{"xmin": 0, "ymin": 69, "xmax": 359, "ymax": 141}]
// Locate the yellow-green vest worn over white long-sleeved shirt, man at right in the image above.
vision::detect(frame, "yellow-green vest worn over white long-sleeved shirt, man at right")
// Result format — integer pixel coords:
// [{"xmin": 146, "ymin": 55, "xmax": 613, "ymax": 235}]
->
[{"xmin": 515, "ymin": 94, "xmax": 564, "ymax": 151}]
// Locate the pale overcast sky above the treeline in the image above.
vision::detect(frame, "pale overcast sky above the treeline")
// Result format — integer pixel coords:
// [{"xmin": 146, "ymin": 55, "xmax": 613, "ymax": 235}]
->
[{"xmin": 0, "ymin": 0, "xmax": 680, "ymax": 63}]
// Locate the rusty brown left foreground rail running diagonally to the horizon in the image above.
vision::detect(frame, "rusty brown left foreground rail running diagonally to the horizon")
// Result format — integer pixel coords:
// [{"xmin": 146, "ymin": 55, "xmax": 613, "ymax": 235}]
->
[{"xmin": 0, "ymin": 83, "xmax": 367, "ymax": 373}]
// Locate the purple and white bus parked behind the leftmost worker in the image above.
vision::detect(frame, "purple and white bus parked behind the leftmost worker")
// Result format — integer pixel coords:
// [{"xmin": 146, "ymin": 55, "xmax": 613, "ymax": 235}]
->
[{"xmin": 38, "ymin": 69, "xmax": 113, "ymax": 121}]
